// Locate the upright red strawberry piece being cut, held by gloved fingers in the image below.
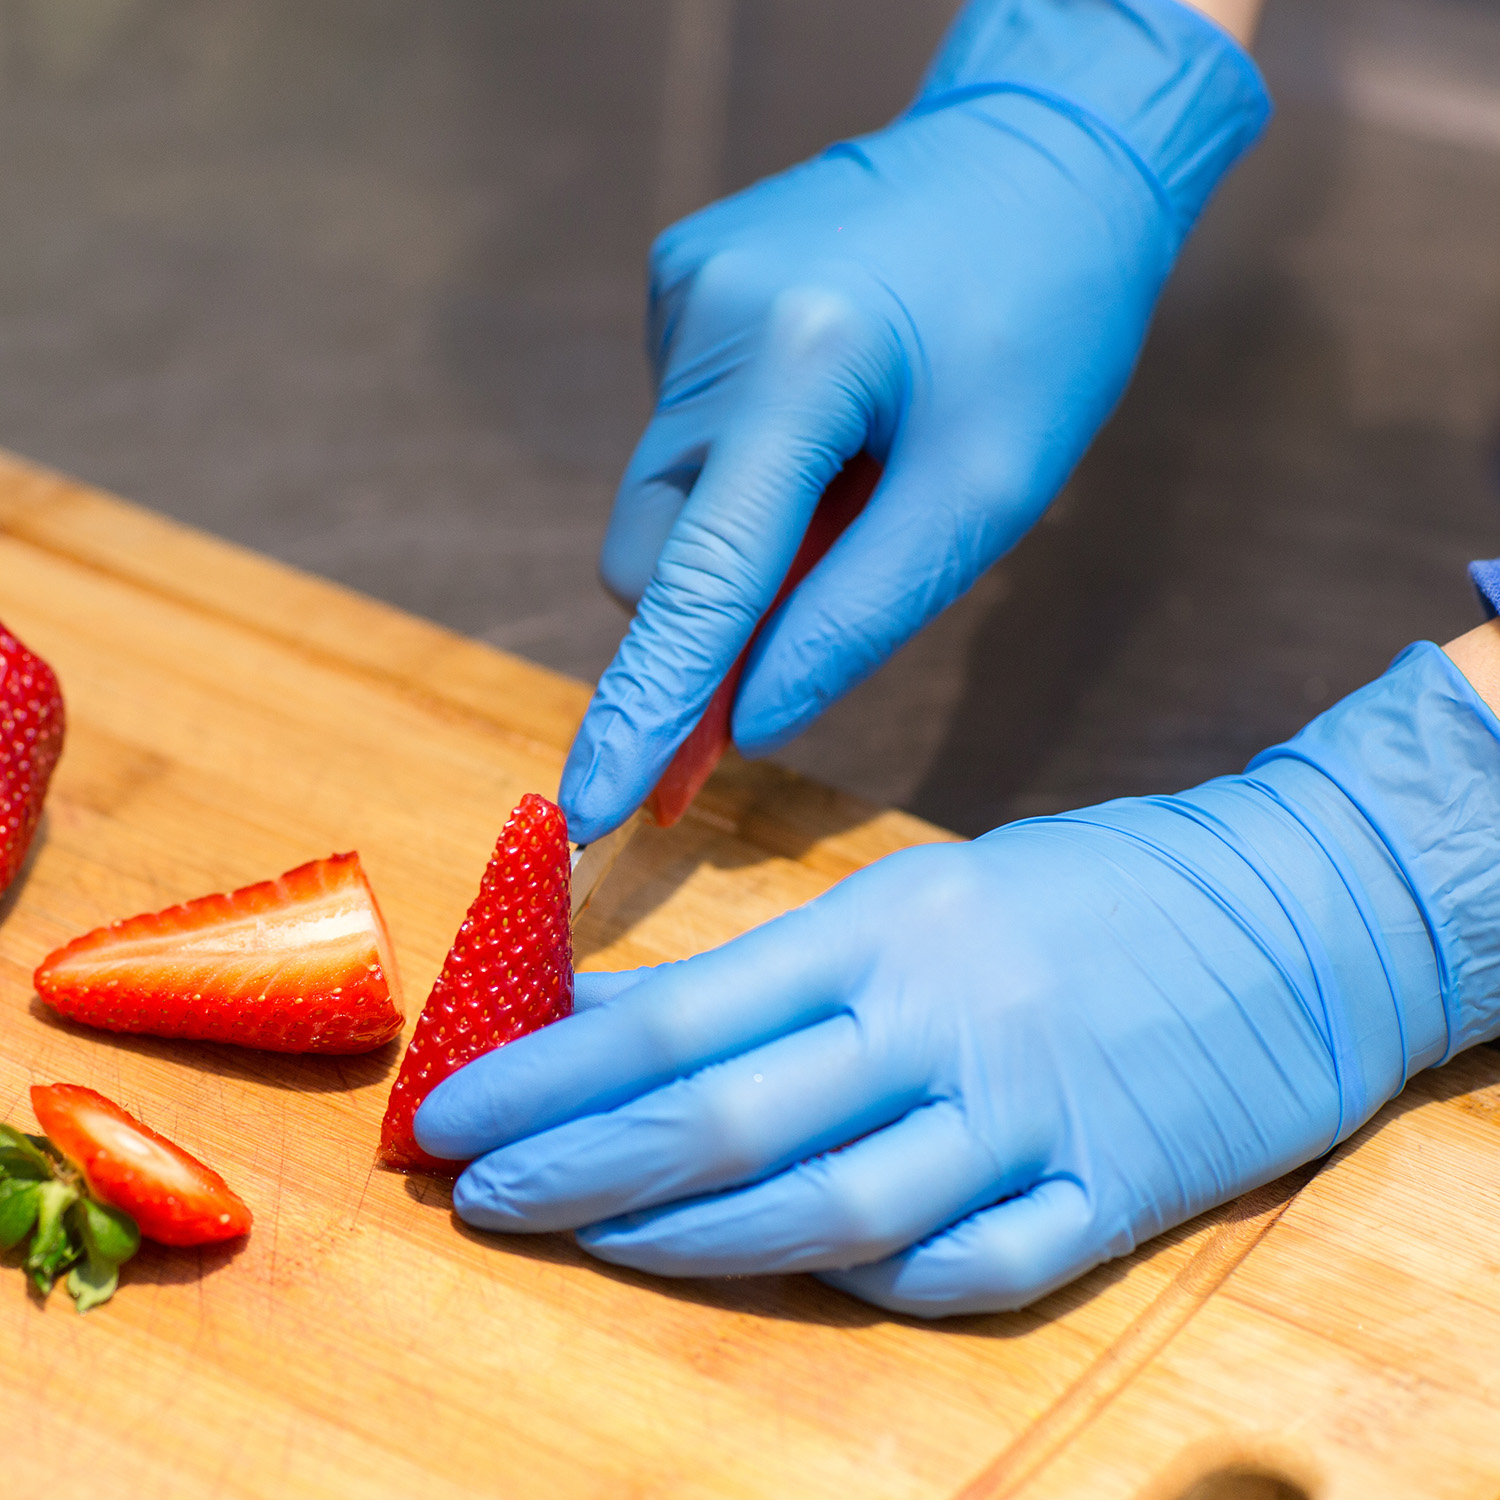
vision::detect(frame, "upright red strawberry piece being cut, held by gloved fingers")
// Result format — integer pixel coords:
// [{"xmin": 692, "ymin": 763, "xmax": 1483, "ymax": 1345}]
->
[{"xmin": 380, "ymin": 792, "xmax": 573, "ymax": 1173}]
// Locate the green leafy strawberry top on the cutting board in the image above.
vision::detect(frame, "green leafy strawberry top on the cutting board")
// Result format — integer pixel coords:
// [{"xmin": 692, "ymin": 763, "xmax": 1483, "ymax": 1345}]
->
[{"xmin": 0, "ymin": 1125, "xmax": 141, "ymax": 1313}]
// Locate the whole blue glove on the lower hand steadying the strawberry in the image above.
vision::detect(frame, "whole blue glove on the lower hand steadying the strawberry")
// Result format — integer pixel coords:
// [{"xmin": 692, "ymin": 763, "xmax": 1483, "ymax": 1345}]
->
[{"xmin": 417, "ymin": 645, "xmax": 1500, "ymax": 1316}]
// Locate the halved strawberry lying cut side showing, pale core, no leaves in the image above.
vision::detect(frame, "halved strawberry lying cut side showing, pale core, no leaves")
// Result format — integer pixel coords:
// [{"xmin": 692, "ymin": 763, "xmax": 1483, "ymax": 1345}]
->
[{"xmin": 35, "ymin": 854, "xmax": 402, "ymax": 1053}]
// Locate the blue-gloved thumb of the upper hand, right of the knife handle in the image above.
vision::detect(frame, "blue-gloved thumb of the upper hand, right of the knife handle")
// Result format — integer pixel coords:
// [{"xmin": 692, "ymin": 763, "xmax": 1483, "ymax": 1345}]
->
[{"xmin": 734, "ymin": 435, "xmax": 1037, "ymax": 755}]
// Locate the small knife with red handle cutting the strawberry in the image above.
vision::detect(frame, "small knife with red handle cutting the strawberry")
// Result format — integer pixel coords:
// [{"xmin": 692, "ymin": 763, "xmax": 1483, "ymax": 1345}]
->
[{"xmin": 573, "ymin": 453, "xmax": 881, "ymax": 921}]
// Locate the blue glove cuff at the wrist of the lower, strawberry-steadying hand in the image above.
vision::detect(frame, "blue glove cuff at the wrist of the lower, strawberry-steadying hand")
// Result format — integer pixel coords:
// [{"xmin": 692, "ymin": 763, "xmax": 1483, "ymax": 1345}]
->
[{"xmin": 1247, "ymin": 641, "xmax": 1500, "ymax": 1067}]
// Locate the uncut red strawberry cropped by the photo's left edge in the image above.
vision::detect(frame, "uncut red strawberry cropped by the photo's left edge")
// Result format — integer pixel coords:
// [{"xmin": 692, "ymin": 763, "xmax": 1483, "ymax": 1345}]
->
[{"xmin": 0, "ymin": 626, "xmax": 63, "ymax": 891}]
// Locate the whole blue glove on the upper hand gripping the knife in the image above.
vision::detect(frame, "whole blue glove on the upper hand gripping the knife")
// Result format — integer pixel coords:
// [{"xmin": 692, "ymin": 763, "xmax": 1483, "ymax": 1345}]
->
[{"xmin": 560, "ymin": 0, "xmax": 1269, "ymax": 843}]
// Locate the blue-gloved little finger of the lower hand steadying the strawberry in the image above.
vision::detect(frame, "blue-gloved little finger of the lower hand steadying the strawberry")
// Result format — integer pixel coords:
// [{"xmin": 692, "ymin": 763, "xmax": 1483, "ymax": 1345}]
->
[{"xmin": 821, "ymin": 1178, "xmax": 1106, "ymax": 1317}]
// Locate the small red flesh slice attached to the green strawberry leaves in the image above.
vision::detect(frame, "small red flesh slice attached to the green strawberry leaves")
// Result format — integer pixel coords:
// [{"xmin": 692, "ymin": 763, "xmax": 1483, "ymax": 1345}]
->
[{"xmin": 32, "ymin": 1083, "xmax": 251, "ymax": 1245}]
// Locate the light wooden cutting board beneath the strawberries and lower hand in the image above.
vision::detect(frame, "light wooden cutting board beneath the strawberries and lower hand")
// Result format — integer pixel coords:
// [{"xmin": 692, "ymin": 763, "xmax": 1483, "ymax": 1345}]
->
[{"xmin": 0, "ymin": 458, "xmax": 1500, "ymax": 1500}]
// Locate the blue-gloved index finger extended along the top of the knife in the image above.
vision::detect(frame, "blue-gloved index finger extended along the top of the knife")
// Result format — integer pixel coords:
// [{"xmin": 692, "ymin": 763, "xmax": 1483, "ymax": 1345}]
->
[{"xmin": 558, "ymin": 282, "xmax": 893, "ymax": 843}]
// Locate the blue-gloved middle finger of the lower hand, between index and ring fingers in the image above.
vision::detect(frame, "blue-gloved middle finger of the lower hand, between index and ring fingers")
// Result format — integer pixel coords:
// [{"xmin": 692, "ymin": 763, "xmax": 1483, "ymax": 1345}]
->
[{"xmin": 453, "ymin": 1016, "xmax": 927, "ymax": 1233}]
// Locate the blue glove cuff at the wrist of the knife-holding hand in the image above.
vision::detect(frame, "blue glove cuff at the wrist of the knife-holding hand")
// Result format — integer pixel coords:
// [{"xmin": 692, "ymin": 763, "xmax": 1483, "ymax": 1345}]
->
[{"xmin": 912, "ymin": 0, "xmax": 1271, "ymax": 240}]
